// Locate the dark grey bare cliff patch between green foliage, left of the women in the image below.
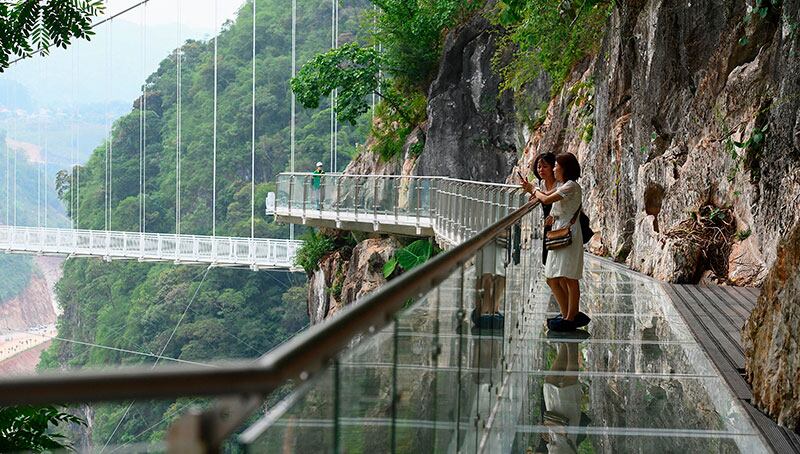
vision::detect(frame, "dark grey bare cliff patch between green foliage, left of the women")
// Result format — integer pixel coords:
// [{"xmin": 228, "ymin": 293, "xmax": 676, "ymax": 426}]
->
[{"xmin": 415, "ymin": 15, "xmax": 520, "ymax": 182}]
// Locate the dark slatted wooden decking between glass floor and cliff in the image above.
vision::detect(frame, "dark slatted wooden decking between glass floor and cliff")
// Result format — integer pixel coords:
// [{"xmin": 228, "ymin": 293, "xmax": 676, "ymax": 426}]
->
[{"xmin": 664, "ymin": 284, "xmax": 800, "ymax": 454}]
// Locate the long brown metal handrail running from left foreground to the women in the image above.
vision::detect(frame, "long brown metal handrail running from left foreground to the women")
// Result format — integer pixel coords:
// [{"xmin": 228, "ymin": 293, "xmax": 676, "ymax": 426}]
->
[{"xmin": 0, "ymin": 201, "xmax": 538, "ymax": 414}]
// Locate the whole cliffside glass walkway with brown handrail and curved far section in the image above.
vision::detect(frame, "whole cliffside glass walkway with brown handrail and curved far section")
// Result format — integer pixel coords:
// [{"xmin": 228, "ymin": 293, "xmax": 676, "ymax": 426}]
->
[{"xmin": 0, "ymin": 178, "xmax": 770, "ymax": 454}]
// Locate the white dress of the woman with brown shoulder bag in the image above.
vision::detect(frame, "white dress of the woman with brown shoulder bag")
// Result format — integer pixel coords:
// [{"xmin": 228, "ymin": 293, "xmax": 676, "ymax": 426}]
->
[{"xmin": 544, "ymin": 180, "xmax": 583, "ymax": 279}]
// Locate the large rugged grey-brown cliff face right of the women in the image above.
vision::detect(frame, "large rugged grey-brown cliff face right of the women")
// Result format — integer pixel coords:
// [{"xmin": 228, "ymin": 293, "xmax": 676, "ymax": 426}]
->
[{"xmin": 522, "ymin": 0, "xmax": 800, "ymax": 285}]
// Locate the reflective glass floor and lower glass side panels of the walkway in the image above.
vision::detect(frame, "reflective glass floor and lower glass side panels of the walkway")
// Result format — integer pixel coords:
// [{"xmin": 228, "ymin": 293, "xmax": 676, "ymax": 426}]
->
[{"xmin": 248, "ymin": 254, "xmax": 767, "ymax": 454}]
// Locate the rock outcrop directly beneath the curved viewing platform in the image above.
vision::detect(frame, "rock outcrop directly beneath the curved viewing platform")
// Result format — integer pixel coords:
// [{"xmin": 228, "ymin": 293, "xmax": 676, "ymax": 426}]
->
[{"xmin": 308, "ymin": 237, "xmax": 400, "ymax": 325}]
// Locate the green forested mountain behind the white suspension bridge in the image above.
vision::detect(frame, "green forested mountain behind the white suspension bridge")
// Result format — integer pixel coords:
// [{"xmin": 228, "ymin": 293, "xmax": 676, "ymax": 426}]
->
[{"xmin": 40, "ymin": 0, "xmax": 367, "ymax": 446}]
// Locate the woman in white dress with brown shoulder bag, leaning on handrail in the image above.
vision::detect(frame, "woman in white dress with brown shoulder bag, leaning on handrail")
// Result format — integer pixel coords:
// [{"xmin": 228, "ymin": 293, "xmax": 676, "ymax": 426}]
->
[{"xmin": 533, "ymin": 153, "xmax": 590, "ymax": 331}]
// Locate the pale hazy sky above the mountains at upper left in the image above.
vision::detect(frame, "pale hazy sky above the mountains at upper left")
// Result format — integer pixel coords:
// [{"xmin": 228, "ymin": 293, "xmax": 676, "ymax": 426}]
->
[{"xmin": 0, "ymin": 0, "xmax": 250, "ymax": 106}]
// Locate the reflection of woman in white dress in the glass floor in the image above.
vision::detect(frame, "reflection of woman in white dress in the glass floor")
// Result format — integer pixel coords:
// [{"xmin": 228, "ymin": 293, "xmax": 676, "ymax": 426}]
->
[{"xmin": 537, "ymin": 336, "xmax": 588, "ymax": 454}]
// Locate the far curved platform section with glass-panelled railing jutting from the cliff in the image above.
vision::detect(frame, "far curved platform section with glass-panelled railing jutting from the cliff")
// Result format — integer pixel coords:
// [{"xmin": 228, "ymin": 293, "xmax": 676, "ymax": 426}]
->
[{"xmin": 274, "ymin": 173, "xmax": 527, "ymax": 245}]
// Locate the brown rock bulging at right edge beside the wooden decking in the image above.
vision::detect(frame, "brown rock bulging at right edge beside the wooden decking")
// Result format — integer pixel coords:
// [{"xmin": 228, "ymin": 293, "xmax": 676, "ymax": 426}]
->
[{"xmin": 742, "ymin": 223, "xmax": 800, "ymax": 432}]
